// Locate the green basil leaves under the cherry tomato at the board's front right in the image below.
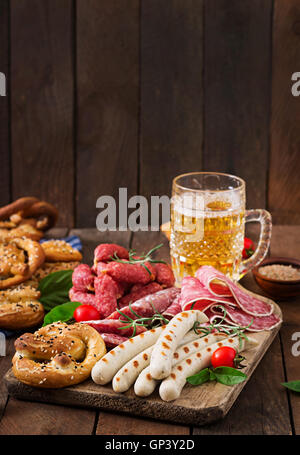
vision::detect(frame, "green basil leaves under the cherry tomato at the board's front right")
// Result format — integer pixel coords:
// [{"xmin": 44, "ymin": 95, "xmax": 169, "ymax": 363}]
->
[{"xmin": 186, "ymin": 367, "xmax": 247, "ymax": 386}]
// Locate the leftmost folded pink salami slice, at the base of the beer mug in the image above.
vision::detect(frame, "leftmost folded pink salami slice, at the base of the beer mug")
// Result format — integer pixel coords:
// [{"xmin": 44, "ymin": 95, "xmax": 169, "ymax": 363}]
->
[{"xmin": 180, "ymin": 276, "xmax": 236, "ymax": 311}]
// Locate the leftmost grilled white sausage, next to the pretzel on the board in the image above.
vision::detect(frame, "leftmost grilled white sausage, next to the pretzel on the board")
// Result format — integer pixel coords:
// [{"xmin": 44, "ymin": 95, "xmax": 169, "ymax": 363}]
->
[{"xmin": 92, "ymin": 326, "xmax": 165, "ymax": 385}]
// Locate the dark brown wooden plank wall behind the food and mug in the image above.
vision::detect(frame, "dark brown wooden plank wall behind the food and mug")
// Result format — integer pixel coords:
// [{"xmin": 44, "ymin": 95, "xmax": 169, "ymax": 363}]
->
[{"xmin": 0, "ymin": 0, "xmax": 300, "ymax": 227}]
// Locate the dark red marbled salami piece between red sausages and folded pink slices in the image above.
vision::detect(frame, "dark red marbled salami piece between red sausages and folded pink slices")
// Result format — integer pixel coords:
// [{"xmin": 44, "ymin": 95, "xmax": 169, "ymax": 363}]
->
[{"xmin": 108, "ymin": 287, "xmax": 180, "ymax": 319}]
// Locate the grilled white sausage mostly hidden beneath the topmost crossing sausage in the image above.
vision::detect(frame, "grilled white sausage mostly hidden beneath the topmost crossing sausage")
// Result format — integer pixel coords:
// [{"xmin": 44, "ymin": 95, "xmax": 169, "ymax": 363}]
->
[{"xmin": 134, "ymin": 332, "xmax": 228, "ymax": 397}]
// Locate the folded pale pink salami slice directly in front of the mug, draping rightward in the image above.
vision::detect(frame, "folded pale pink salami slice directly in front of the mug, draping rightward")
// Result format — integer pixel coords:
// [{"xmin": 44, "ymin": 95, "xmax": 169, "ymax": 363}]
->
[{"xmin": 196, "ymin": 265, "xmax": 273, "ymax": 316}]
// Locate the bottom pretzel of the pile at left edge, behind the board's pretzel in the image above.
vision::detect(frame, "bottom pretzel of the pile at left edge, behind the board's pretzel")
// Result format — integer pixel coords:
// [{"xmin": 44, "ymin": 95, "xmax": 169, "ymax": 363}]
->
[{"xmin": 0, "ymin": 285, "xmax": 44, "ymax": 330}]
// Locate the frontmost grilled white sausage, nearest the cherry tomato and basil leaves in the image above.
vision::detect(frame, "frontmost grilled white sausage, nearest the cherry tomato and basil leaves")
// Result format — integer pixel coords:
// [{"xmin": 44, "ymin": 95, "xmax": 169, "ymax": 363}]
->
[{"xmin": 159, "ymin": 337, "xmax": 257, "ymax": 401}]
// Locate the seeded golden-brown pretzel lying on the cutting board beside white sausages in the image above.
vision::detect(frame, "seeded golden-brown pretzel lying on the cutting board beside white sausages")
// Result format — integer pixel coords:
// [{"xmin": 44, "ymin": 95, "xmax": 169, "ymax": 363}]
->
[{"xmin": 12, "ymin": 322, "xmax": 106, "ymax": 389}]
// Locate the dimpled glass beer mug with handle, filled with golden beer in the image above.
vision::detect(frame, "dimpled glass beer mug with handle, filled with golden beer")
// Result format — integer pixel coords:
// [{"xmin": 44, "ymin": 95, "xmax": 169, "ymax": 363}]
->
[{"xmin": 170, "ymin": 172, "xmax": 272, "ymax": 284}]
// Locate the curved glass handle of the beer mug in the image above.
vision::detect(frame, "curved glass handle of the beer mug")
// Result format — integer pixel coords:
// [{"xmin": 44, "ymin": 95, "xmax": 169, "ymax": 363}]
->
[{"xmin": 240, "ymin": 209, "xmax": 272, "ymax": 278}]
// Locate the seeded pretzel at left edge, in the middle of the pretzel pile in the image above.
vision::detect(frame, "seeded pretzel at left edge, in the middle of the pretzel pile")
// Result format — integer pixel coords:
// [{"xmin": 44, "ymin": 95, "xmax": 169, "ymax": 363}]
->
[{"xmin": 0, "ymin": 239, "xmax": 45, "ymax": 289}]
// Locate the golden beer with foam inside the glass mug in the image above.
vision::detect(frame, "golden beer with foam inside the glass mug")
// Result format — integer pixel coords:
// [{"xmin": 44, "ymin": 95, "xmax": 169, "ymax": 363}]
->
[{"xmin": 170, "ymin": 196, "xmax": 245, "ymax": 283}]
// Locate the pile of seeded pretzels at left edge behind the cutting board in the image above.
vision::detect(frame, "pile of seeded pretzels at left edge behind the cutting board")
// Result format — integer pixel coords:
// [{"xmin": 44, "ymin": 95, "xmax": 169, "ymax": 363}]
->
[{"xmin": 0, "ymin": 197, "xmax": 82, "ymax": 330}]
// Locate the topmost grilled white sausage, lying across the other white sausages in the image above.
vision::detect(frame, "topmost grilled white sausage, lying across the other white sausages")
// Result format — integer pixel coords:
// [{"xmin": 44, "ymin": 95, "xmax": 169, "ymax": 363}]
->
[{"xmin": 150, "ymin": 310, "xmax": 208, "ymax": 379}]
